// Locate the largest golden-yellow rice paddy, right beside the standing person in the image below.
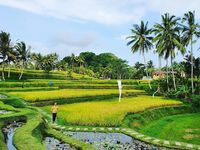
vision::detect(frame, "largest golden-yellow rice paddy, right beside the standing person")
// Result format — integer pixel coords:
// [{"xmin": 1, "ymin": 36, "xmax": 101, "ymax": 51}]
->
[{"xmin": 43, "ymin": 96, "xmax": 182, "ymax": 126}]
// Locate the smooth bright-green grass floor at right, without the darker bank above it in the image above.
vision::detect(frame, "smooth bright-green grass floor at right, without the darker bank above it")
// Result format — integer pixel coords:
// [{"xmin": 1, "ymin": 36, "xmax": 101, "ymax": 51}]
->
[{"xmin": 140, "ymin": 113, "xmax": 200, "ymax": 145}]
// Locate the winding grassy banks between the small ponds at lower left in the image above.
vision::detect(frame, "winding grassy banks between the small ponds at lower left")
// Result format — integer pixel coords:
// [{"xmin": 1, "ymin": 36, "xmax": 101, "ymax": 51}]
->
[{"xmin": 0, "ymin": 94, "xmax": 94, "ymax": 150}]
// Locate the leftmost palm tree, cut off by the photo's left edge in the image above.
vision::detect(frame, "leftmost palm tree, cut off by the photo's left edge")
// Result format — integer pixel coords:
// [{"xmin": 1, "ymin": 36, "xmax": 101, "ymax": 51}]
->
[{"xmin": 0, "ymin": 31, "xmax": 11, "ymax": 80}]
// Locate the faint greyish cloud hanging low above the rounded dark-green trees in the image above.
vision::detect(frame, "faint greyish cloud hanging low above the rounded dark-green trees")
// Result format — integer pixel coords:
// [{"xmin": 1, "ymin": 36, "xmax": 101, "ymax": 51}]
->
[{"xmin": 29, "ymin": 32, "xmax": 99, "ymax": 59}]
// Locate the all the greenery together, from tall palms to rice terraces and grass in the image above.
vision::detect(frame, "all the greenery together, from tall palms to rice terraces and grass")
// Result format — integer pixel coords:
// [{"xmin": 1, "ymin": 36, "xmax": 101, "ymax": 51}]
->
[{"xmin": 0, "ymin": 11, "xmax": 200, "ymax": 150}]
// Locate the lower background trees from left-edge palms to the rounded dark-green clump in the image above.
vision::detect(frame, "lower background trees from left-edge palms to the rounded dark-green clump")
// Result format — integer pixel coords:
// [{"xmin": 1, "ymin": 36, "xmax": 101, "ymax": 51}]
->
[{"xmin": 0, "ymin": 36, "xmax": 154, "ymax": 80}]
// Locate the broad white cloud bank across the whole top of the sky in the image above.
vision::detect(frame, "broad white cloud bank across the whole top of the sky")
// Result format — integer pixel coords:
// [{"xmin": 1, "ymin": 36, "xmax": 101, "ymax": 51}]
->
[{"xmin": 0, "ymin": 0, "xmax": 200, "ymax": 25}]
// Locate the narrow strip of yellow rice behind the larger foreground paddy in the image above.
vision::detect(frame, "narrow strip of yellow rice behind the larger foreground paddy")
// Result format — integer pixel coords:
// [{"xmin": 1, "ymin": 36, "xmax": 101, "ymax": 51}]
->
[{"xmin": 8, "ymin": 89, "xmax": 144, "ymax": 102}]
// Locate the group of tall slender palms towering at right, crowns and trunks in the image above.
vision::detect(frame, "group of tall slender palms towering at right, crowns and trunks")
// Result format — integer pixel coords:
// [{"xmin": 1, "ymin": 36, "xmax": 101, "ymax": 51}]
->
[{"xmin": 127, "ymin": 11, "xmax": 200, "ymax": 93}]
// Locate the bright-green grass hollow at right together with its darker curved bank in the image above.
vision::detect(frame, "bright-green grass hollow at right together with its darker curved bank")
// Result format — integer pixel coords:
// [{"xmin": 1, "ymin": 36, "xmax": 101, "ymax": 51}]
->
[{"xmin": 123, "ymin": 106, "xmax": 200, "ymax": 144}]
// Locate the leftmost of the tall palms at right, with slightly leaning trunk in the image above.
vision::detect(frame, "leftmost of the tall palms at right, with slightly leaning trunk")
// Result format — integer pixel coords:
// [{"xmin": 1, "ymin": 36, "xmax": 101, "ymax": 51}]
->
[{"xmin": 127, "ymin": 21, "xmax": 153, "ymax": 88}]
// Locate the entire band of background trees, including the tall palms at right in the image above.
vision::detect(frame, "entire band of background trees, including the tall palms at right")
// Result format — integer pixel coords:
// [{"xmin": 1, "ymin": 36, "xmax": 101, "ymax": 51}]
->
[{"xmin": 0, "ymin": 12, "xmax": 200, "ymax": 94}]
